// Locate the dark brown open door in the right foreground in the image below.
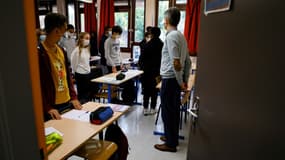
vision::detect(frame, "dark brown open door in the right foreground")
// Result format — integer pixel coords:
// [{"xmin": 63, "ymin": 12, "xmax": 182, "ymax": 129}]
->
[{"xmin": 187, "ymin": 0, "xmax": 285, "ymax": 160}]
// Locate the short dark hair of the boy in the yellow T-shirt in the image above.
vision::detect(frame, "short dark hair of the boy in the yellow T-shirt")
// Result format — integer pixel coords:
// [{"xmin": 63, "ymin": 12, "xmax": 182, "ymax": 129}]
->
[{"xmin": 45, "ymin": 13, "xmax": 66, "ymax": 33}]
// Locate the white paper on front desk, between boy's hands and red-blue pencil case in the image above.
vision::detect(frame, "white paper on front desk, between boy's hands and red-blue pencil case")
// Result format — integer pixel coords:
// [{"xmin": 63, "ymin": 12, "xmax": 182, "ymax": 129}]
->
[{"xmin": 62, "ymin": 109, "xmax": 90, "ymax": 122}]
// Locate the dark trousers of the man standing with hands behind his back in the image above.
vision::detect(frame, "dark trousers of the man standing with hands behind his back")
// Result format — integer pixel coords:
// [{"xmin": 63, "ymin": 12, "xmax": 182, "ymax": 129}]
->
[{"xmin": 160, "ymin": 78, "xmax": 181, "ymax": 148}]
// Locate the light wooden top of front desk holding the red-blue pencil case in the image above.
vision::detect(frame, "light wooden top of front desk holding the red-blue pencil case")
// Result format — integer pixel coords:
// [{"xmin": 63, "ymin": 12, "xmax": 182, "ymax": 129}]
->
[{"xmin": 45, "ymin": 102, "xmax": 127, "ymax": 160}]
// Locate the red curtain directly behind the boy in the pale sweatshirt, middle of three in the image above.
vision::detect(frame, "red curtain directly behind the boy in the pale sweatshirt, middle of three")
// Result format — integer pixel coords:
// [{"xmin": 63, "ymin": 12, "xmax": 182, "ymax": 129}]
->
[{"xmin": 99, "ymin": 0, "xmax": 115, "ymax": 37}]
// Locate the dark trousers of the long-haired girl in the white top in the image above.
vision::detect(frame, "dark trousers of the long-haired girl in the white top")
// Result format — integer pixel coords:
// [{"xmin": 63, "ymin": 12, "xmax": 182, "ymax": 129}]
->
[{"xmin": 75, "ymin": 73, "xmax": 91, "ymax": 102}]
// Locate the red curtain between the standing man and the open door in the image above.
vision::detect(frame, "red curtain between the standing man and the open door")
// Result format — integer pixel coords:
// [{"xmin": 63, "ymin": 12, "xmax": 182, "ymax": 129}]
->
[{"xmin": 184, "ymin": 0, "xmax": 201, "ymax": 56}]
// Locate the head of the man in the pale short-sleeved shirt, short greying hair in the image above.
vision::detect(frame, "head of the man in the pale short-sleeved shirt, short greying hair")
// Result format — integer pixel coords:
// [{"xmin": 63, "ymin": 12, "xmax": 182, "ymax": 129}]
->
[{"xmin": 164, "ymin": 7, "xmax": 180, "ymax": 27}]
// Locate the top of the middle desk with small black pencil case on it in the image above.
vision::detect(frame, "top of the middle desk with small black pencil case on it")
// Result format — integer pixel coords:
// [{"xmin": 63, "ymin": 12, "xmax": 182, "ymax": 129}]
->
[{"xmin": 91, "ymin": 69, "xmax": 143, "ymax": 85}]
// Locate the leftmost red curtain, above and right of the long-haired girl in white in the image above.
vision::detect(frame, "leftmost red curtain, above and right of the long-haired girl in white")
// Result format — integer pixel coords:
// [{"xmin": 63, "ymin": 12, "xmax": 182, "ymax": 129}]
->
[{"xmin": 84, "ymin": 1, "xmax": 97, "ymax": 33}]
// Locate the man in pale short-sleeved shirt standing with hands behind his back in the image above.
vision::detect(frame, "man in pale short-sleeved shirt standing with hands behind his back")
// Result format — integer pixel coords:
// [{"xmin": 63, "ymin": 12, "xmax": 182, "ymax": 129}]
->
[{"xmin": 154, "ymin": 8, "xmax": 191, "ymax": 152}]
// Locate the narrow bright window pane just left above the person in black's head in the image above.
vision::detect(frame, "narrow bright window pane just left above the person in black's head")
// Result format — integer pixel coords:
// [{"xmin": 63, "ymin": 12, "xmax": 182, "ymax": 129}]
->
[{"xmin": 134, "ymin": 0, "xmax": 145, "ymax": 42}]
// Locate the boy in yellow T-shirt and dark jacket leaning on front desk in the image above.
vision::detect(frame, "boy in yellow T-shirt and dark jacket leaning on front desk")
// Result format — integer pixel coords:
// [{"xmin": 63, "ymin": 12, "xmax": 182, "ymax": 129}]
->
[{"xmin": 38, "ymin": 13, "xmax": 82, "ymax": 120}]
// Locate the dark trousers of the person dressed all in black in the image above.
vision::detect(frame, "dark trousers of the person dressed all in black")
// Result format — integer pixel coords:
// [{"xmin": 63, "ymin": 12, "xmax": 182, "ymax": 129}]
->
[{"xmin": 141, "ymin": 72, "xmax": 158, "ymax": 109}]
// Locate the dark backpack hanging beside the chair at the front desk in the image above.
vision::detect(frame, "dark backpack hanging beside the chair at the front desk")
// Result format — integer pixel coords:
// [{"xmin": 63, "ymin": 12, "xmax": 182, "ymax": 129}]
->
[{"xmin": 105, "ymin": 124, "xmax": 129, "ymax": 160}]
